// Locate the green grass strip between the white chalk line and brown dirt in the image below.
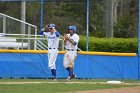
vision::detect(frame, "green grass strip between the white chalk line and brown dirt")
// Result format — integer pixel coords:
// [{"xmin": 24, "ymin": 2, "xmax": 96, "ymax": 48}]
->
[{"xmin": 0, "ymin": 83, "xmax": 136, "ymax": 93}]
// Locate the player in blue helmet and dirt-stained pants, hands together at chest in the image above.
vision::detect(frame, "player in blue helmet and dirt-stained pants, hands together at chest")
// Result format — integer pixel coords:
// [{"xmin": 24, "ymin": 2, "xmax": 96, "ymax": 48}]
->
[{"xmin": 63, "ymin": 25, "xmax": 79, "ymax": 81}]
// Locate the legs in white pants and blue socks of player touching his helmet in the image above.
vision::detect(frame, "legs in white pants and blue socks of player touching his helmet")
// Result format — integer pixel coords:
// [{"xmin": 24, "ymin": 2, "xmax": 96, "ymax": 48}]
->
[{"xmin": 48, "ymin": 50, "xmax": 58, "ymax": 80}]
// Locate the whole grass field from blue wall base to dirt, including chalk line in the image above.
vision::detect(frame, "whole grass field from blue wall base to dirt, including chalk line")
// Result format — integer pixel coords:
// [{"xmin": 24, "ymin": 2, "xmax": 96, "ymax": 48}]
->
[{"xmin": 0, "ymin": 79, "xmax": 140, "ymax": 93}]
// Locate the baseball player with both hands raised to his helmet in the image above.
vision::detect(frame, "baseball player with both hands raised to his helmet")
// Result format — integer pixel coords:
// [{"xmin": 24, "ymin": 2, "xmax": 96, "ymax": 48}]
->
[{"xmin": 41, "ymin": 24, "xmax": 60, "ymax": 81}]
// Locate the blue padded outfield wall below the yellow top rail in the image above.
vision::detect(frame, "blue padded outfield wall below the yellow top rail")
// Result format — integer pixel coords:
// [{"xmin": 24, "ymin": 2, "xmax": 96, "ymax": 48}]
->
[{"xmin": 0, "ymin": 53, "xmax": 140, "ymax": 79}]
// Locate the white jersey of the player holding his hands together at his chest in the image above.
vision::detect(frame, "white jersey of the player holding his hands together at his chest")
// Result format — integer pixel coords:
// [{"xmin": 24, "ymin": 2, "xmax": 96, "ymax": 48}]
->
[{"xmin": 65, "ymin": 33, "xmax": 79, "ymax": 50}]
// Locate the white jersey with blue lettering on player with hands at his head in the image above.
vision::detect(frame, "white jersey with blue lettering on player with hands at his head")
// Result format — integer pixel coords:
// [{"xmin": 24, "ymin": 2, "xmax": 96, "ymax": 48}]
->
[{"xmin": 43, "ymin": 32, "xmax": 60, "ymax": 48}]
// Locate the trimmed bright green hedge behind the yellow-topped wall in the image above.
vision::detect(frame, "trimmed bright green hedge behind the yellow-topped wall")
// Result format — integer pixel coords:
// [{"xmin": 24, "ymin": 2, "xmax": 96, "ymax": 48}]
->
[{"xmin": 78, "ymin": 36, "xmax": 138, "ymax": 53}]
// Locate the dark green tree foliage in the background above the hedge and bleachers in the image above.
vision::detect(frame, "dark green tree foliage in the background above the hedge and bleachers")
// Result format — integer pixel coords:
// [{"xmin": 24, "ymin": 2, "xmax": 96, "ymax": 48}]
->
[{"xmin": 0, "ymin": 0, "xmax": 138, "ymax": 38}]
